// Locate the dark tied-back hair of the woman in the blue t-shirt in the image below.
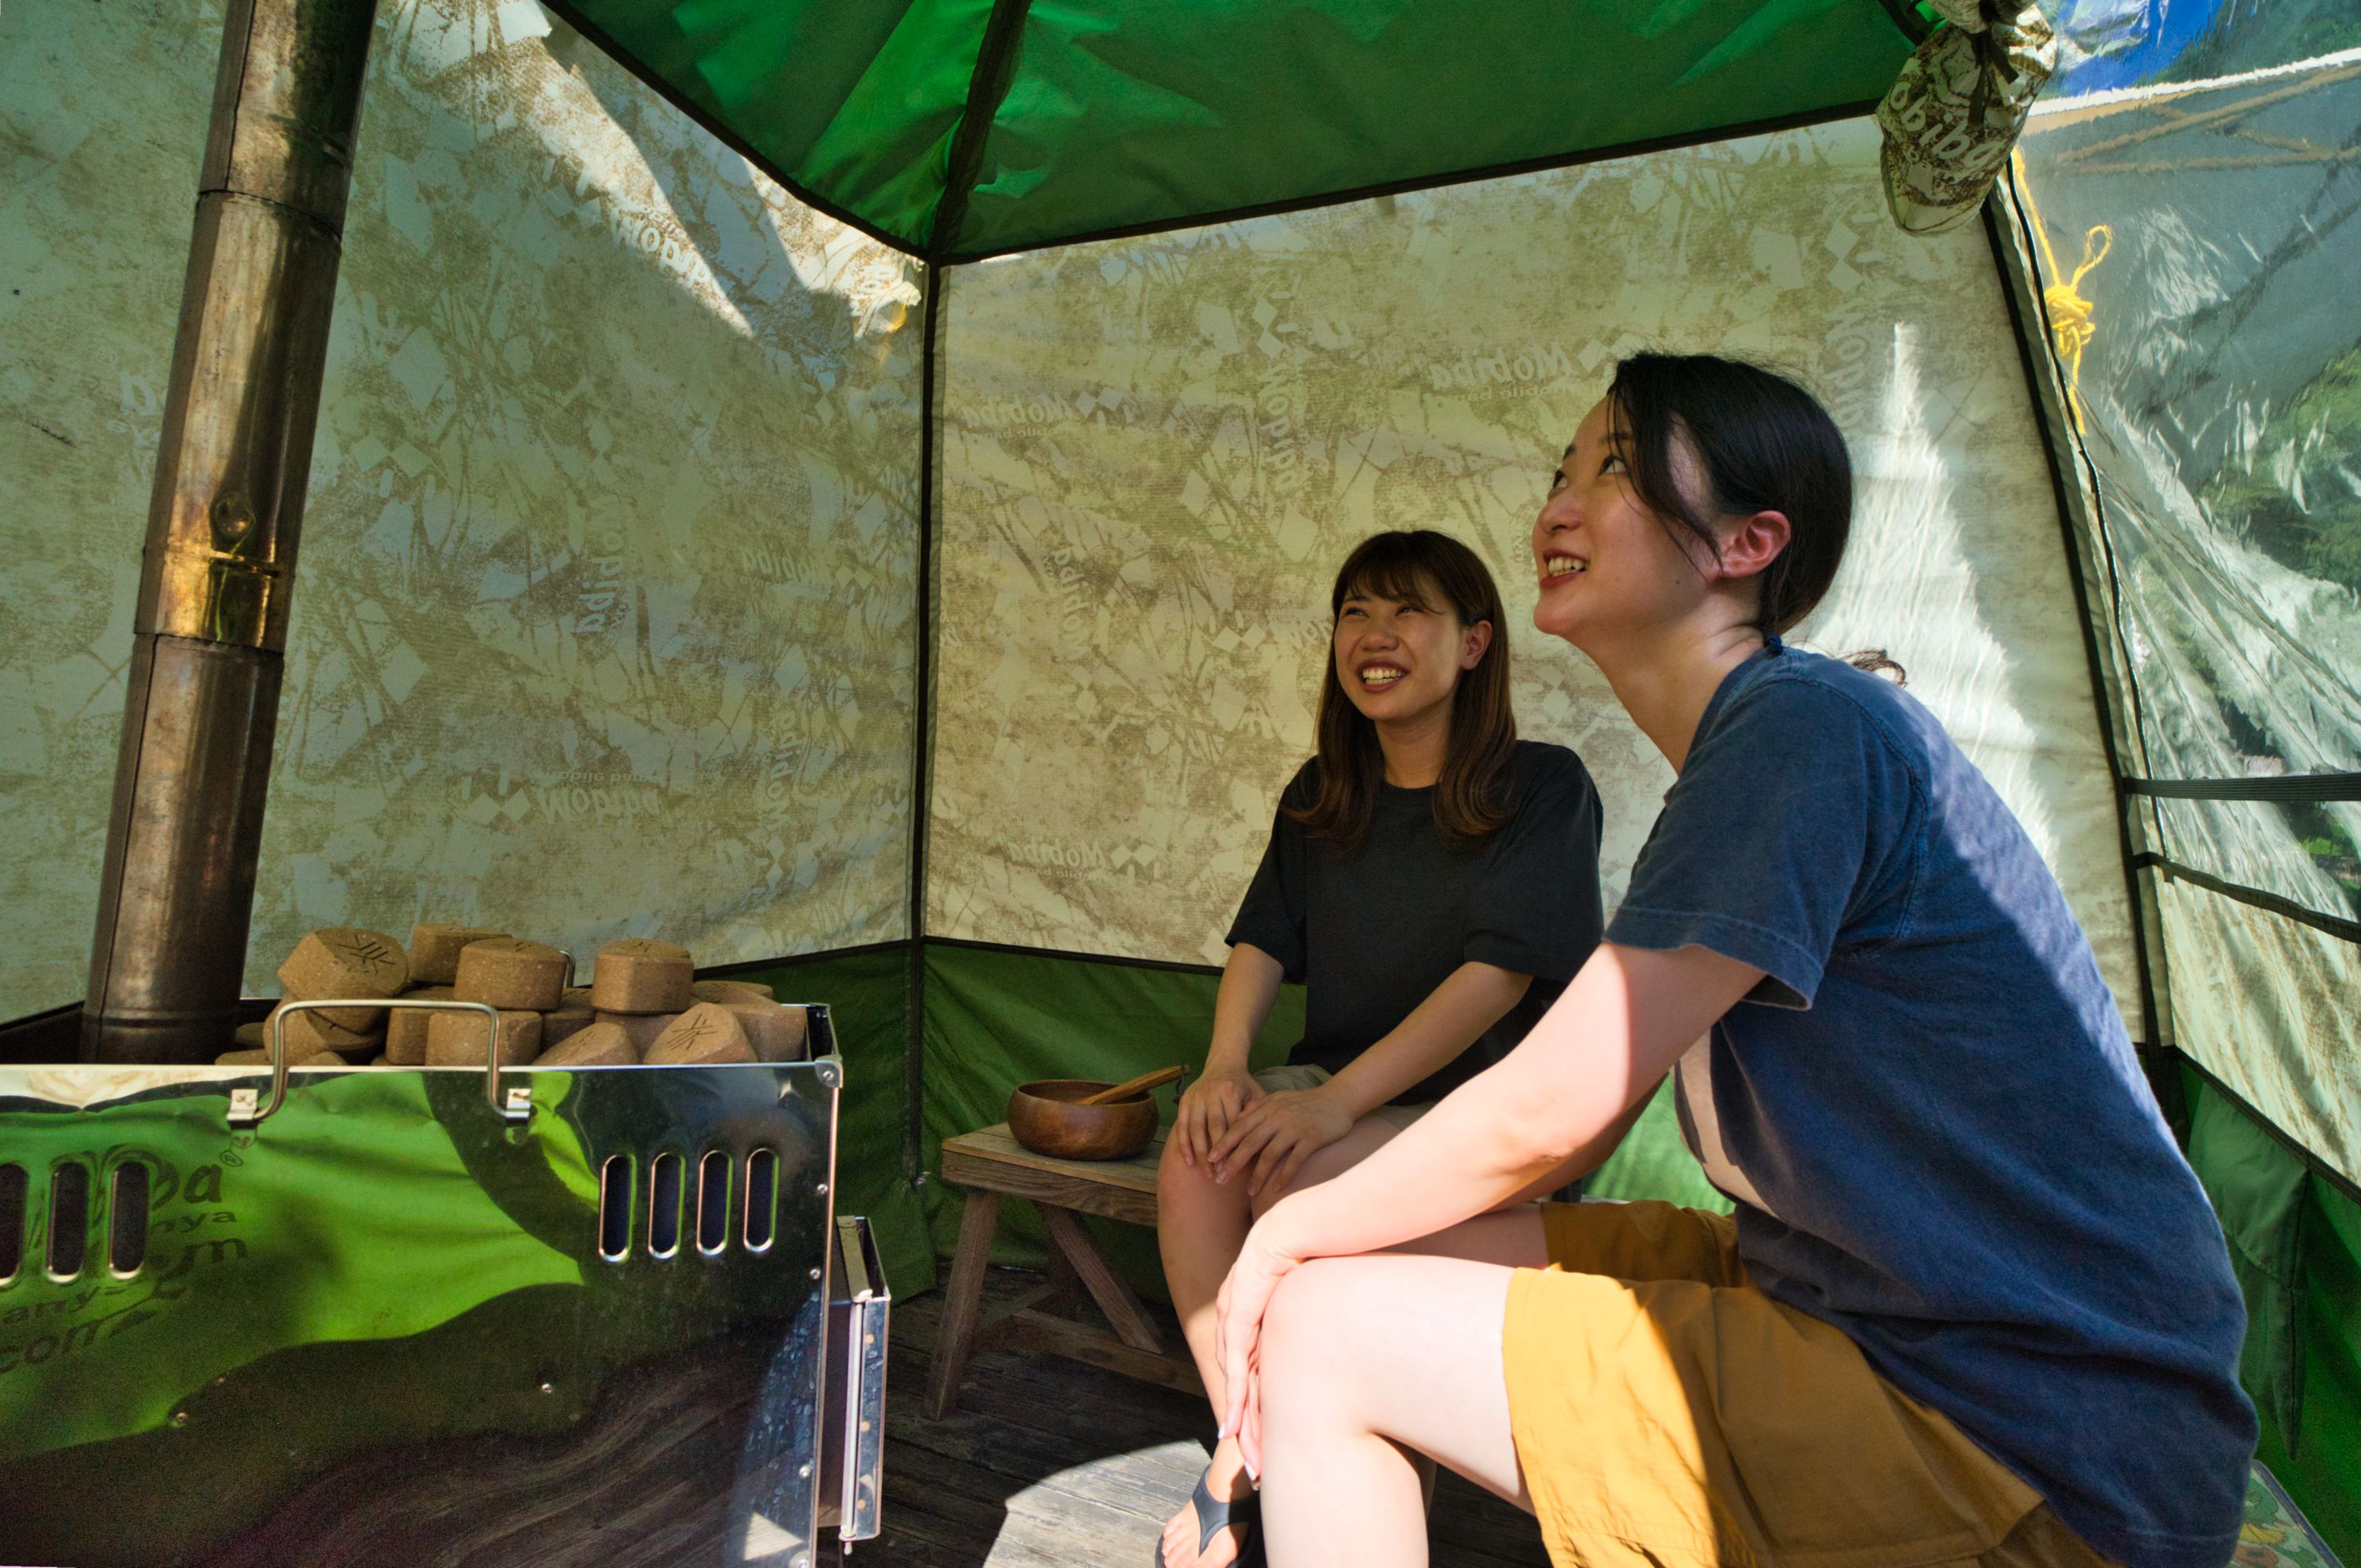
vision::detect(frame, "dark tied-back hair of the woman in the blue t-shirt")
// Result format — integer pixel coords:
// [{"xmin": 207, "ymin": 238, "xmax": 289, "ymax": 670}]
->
[{"xmin": 1608, "ymin": 354, "xmax": 1854, "ymax": 635}]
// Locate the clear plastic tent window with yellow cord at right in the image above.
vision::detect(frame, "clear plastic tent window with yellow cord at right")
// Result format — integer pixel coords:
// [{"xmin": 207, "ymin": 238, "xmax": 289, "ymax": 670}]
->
[{"xmin": 2021, "ymin": 50, "xmax": 2361, "ymax": 1176}]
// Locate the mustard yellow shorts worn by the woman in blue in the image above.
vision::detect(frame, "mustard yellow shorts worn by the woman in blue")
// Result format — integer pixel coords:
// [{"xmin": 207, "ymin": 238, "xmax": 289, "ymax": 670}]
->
[{"xmin": 1502, "ymin": 1202, "xmax": 2108, "ymax": 1568}]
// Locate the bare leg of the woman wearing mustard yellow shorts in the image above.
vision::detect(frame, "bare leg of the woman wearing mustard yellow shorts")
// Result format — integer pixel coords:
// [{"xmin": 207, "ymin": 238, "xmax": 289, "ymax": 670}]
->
[{"xmin": 1259, "ymin": 1246, "xmax": 1540, "ymax": 1568}]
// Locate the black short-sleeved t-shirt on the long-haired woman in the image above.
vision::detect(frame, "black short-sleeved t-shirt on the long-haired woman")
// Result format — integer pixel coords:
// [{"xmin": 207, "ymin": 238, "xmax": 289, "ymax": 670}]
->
[{"xmin": 1228, "ymin": 741, "xmax": 1601, "ymax": 1105}]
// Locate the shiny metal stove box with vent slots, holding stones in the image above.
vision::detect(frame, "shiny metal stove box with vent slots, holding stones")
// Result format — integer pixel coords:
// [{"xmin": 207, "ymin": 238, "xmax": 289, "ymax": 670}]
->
[{"xmin": 0, "ymin": 999, "xmax": 890, "ymax": 1568}]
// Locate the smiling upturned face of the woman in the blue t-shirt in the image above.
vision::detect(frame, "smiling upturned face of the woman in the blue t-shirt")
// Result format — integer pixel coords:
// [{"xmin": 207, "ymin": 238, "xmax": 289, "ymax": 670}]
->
[{"xmin": 1533, "ymin": 399, "xmax": 1710, "ymax": 649}]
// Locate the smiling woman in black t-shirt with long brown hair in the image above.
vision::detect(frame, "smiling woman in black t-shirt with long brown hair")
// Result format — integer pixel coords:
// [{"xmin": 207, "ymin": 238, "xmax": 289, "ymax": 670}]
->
[{"xmin": 1157, "ymin": 529, "xmax": 1601, "ymax": 1568}]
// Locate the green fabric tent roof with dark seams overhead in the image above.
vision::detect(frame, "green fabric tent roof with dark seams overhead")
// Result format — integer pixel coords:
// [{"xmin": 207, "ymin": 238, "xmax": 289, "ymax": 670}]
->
[{"xmin": 555, "ymin": 0, "xmax": 1917, "ymax": 260}]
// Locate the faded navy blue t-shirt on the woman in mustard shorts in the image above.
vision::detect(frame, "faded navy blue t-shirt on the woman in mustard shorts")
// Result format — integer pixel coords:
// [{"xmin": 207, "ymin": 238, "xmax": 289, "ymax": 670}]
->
[{"xmin": 1608, "ymin": 640, "xmax": 2255, "ymax": 1568}]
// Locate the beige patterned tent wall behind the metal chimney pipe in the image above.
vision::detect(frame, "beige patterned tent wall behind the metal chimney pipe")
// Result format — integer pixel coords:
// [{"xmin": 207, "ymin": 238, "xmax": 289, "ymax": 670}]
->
[{"xmin": 0, "ymin": 0, "xmax": 918, "ymax": 1018}]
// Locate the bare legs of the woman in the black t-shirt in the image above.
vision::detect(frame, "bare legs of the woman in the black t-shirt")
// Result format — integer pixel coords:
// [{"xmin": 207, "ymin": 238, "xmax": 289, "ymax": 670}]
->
[{"xmin": 1157, "ymin": 1117, "xmax": 1396, "ymax": 1568}]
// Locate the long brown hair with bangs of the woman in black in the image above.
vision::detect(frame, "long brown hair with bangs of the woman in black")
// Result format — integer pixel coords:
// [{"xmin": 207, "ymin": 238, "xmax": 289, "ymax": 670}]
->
[{"xmin": 1285, "ymin": 529, "xmax": 1516, "ymax": 855}]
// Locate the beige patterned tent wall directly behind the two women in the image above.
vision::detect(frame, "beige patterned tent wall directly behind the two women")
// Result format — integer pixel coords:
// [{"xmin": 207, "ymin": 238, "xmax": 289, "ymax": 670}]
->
[{"xmin": 928, "ymin": 110, "xmax": 2137, "ymax": 1016}]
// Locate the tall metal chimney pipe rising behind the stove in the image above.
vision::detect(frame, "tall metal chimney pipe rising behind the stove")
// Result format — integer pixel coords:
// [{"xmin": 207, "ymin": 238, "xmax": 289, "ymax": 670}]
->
[{"xmin": 83, "ymin": 0, "xmax": 375, "ymax": 1063}]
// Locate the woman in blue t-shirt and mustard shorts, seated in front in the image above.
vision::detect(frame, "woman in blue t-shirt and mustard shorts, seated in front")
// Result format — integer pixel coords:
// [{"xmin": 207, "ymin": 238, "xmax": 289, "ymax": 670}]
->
[{"xmin": 1221, "ymin": 354, "xmax": 2255, "ymax": 1568}]
